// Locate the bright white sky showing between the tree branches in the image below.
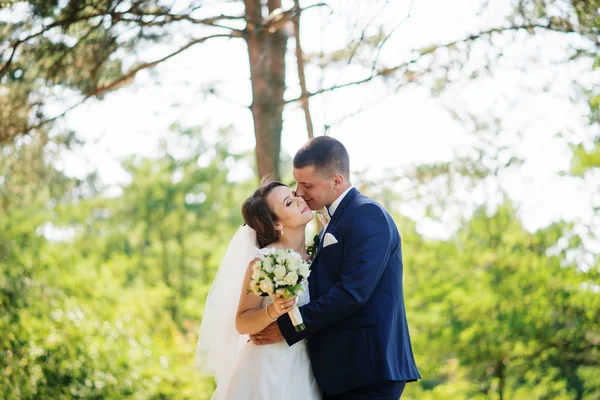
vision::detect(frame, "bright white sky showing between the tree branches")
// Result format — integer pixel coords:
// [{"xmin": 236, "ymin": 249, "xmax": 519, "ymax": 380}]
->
[{"xmin": 54, "ymin": 0, "xmax": 598, "ymax": 244}]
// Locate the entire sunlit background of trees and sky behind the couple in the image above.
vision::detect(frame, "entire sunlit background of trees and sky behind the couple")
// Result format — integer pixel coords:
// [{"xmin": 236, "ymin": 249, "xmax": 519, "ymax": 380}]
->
[{"xmin": 0, "ymin": 0, "xmax": 600, "ymax": 399}]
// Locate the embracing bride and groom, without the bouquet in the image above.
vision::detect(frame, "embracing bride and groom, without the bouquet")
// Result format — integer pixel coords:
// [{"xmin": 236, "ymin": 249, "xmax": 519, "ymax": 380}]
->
[{"xmin": 196, "ymin": 136, "xmax": 420, "ymax": 400}]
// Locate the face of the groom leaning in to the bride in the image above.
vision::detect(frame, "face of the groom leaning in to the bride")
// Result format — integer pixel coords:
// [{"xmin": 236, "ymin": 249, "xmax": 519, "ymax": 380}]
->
[{"xmin": 294, "ymin": 165, "xmax": 335, "ymax": 210}]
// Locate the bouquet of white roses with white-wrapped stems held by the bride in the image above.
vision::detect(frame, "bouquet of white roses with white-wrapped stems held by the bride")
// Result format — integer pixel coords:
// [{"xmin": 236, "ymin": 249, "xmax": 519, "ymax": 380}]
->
[{"xmin": 249, "ymin": 249, "xmax": 310, "ymax": 332}]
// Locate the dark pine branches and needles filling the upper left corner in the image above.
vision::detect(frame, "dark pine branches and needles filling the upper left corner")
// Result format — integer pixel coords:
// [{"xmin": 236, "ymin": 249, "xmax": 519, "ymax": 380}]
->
[{"xmin": 0, "ymin": 0, "xmax": 175, "ymax": 143}]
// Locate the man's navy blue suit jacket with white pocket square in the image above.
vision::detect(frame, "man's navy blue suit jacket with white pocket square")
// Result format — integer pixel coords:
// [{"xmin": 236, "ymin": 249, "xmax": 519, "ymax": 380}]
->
[{"xmin": 278, "ymin": 188, "xmax": 421, "ymax": 394}]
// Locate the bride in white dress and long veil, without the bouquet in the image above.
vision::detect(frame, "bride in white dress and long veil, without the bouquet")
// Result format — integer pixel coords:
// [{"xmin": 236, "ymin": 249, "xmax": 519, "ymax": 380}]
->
[{"xmin": 195, "ymin": 182, "xmax": 321, "ymax": 400}]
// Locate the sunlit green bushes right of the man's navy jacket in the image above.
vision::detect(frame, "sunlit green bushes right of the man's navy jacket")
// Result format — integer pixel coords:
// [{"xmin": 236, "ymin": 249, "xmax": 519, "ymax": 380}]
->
[{"xmin": 404, "ymin": 203, "xmax": 600, "ymax": 399}]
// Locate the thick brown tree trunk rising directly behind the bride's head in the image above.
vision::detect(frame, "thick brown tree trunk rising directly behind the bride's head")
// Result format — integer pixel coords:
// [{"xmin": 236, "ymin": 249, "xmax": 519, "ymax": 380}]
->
[{"xmin": 244, "ymin": 0, "xmax": 287, "ymax": 179}]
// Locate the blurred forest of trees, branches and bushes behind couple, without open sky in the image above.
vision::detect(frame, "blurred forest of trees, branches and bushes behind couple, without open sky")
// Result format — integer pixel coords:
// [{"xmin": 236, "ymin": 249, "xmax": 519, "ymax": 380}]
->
[{"xmin": 0, "ymin": 0, "xmax": 600, "ymax": 400}]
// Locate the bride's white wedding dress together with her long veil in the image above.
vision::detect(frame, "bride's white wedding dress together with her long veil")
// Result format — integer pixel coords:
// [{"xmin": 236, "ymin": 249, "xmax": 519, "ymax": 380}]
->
[{"xmin": 195, "ymin": 226, "xmax": 321, "ymax": 400}]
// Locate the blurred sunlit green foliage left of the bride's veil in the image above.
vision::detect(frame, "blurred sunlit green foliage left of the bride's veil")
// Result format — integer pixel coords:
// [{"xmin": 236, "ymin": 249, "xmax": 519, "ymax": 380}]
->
[{"xmin": 0, "ymin": 130, "xmax": 249, "ymax": 399}]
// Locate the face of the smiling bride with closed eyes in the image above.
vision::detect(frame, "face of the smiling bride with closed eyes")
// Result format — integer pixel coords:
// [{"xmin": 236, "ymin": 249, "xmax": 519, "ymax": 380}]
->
[{"xmin": 266, "ymin": 186, "xmax": 313, "ymax": 228}]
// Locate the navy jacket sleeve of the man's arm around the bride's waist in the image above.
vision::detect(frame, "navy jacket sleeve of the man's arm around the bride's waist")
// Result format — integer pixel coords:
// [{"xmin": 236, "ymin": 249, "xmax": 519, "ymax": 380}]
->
[{"xmin": 278, "ymin": 204, "xmax": 392, "ymax": 345}]
